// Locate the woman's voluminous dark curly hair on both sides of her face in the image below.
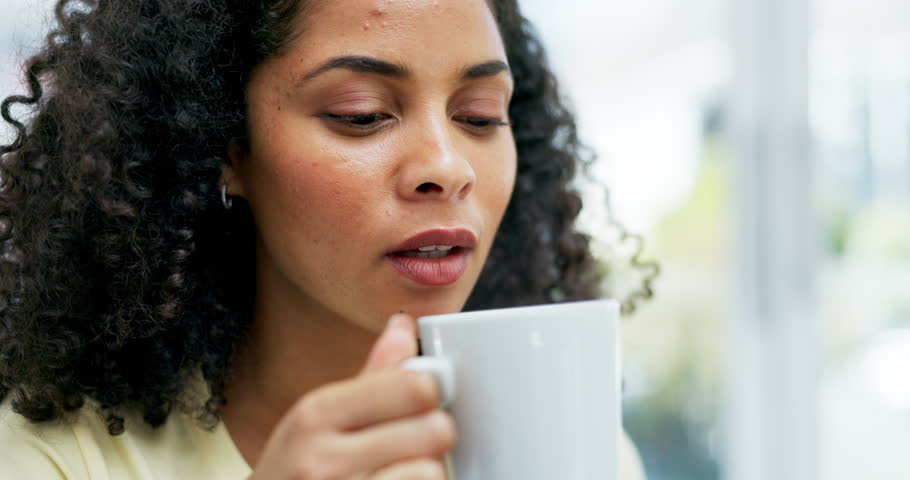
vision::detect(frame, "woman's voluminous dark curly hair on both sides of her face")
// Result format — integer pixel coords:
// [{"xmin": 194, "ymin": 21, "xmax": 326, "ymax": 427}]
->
[{"xmin": 0, "ymin": 0, "xmax": 644, "ymax": 435}]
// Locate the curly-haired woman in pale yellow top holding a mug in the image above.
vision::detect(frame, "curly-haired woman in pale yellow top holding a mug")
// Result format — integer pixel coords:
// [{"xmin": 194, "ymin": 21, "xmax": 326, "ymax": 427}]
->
[{"xmin": 0, "ymin": 0, "xmax": 652, "ymax": 479}]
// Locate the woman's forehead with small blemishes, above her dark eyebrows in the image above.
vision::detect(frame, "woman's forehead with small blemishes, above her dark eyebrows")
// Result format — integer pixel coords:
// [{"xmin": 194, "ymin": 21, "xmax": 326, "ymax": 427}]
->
[{"xmin": 289, "ymin": 0, "xmax": 506, "ymax": 72}]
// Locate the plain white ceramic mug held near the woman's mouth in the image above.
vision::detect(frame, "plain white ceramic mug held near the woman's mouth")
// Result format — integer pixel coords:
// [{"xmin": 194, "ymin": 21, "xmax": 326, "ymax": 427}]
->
[{"xmin": 404, "ymin": 300, "xmax": 621, "ymax": 480}]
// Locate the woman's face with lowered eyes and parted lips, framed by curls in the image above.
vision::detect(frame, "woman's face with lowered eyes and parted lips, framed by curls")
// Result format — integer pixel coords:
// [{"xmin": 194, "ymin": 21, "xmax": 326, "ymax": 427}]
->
[{"xmin": 226, "ymin": 0, "xmax": 516, "ymax": 331}]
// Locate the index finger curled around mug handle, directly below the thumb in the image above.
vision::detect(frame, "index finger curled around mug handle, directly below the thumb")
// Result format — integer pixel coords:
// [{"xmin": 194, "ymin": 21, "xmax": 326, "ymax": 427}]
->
[{"xmin": 299, "ymin": 369, "xmax": 440, "ymax": 430}]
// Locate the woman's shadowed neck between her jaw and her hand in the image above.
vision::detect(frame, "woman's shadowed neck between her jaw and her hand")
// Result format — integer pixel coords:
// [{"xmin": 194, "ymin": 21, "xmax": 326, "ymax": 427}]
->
[{"xmin": 222, "ymin": 253, "xmax": 378, "ymax": 466}]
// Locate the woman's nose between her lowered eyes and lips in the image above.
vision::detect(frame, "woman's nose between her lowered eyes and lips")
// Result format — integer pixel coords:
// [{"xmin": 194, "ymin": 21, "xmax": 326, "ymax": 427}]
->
[{"xmin": 397, "ymin": 117, "xmax": 477, "ymax": 201}]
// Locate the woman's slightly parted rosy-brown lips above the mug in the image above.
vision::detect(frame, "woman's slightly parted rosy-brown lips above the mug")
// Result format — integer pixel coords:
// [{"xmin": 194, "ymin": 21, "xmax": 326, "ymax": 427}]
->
[{"xmin": 386, "ymin": 228, "xmax": 477, "ymax": 287}]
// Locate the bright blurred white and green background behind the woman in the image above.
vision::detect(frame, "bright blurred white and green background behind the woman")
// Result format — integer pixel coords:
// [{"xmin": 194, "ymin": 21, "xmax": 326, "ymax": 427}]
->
[{"xmin": 0, "ymin": 0, "xmax": 910, "ymax": 480}]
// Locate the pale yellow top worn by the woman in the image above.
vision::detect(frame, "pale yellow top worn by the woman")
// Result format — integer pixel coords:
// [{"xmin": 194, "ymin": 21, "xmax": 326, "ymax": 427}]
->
[{"xmin": 0, "ymin": 401, "xmax": 644, "ymax": 480}]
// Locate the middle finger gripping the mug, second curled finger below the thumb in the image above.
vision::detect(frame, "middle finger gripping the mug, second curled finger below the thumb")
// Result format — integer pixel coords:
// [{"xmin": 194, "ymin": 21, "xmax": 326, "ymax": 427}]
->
[{"xmin": 338, "ymin": 410, "xmax": 456, "ymax": 471}]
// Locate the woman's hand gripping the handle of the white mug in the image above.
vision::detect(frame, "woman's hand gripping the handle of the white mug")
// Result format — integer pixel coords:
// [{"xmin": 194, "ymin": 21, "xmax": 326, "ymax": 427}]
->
[{"xmin": 250, "ymin": 314, "xmax": 455, "ymax": 480}]
